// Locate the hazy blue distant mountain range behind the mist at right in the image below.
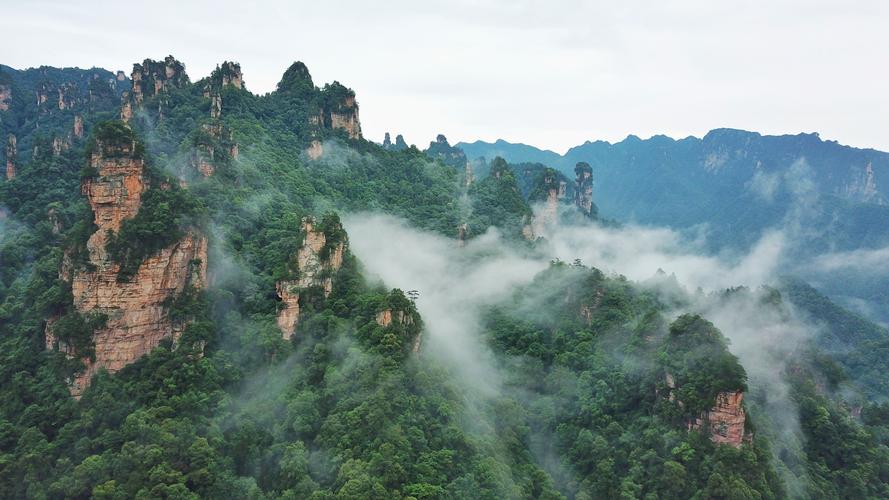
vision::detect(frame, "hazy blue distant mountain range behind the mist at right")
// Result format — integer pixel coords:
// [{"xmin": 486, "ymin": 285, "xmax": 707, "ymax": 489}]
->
[{"xmin": 456, "ymin": 129, "xmax": 889, "ymax": 322}]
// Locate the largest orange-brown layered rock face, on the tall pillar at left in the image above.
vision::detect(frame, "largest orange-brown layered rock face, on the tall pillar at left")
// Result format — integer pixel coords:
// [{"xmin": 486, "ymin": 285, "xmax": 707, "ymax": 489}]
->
[{"xmin": 64, "ymin": 131, "xmax": 207, "ymax": 397}]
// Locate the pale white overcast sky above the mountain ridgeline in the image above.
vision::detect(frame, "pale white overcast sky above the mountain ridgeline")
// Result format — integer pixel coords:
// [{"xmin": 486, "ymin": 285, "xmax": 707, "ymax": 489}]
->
[{"xmin": 0, "ymin": 0, "xmax": 889, "ymax": 152}]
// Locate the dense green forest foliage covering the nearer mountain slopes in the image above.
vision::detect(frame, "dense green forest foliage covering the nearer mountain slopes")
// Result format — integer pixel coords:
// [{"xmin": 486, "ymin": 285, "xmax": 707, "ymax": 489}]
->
[{"xmin": 0, "ymin": 56, "xmax": 889, "ymax": 499}]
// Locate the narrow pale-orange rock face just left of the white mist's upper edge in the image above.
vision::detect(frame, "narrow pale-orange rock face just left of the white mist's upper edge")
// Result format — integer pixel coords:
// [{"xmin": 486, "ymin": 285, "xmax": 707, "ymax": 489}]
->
[{"xmin": 275, "ymin": 217, "xmax": 346, "ymax": 339}]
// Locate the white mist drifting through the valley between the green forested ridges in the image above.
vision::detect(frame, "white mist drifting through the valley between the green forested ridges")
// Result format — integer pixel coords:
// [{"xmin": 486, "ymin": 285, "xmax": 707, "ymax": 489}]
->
[{"xmin": 343, "ymin": 207, "xmax": 817, "ymax": 492}]
